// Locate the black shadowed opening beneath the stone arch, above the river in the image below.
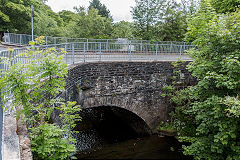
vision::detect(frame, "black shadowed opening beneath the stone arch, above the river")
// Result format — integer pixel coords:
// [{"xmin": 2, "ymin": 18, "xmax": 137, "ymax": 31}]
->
[{"xmin": 74, "ymin": 106, "xmax": 151, "ymax": 151}]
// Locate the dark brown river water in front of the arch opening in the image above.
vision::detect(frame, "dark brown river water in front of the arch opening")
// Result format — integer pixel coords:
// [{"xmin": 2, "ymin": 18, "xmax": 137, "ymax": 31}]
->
[{"xmin": 76, "ymin": 135, "xmax": 191, "ymax": 160}]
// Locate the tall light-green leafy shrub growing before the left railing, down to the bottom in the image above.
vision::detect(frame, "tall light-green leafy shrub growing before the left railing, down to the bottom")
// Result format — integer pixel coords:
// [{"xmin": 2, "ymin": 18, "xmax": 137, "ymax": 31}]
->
[{"xmin": 0, "ymin": 37, "xmax": 81, "ymax": 159}]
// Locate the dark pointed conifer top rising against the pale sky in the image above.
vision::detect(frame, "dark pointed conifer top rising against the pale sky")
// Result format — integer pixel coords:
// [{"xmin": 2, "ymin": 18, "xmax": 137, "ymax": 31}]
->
[{"xmin": 88, "ymin": 0, "xmax": 112, "ymax": 19}]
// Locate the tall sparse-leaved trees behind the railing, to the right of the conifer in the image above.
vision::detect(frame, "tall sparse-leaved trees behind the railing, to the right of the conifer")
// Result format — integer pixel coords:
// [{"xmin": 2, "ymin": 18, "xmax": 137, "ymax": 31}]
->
[{"xmin": 132, "ymin": 0, "xmax": 196, "ymax": 41}]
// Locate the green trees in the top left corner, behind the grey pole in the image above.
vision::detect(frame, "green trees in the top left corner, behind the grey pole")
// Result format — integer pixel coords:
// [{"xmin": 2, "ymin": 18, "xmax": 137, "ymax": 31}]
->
[{"xmin": 0, "ymin": 0, "xmax": 63, "ymax": 36}]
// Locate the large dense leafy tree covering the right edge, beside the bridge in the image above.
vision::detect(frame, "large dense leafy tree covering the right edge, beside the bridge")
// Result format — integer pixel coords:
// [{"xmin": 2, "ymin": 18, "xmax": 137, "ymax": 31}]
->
[{"xmin": 168, "ymin": 0, "xmax": 240, "ymax": 159}]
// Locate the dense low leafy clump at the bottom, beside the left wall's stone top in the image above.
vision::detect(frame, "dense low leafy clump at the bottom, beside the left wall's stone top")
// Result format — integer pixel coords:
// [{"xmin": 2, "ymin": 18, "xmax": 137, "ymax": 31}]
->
[{"xmin": 30, "ymin": 123, "xmax": 76, "ymax": 160}]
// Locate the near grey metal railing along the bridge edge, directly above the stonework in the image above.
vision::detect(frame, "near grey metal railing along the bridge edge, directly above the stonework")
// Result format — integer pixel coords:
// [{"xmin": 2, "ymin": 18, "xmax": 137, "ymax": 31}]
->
[{"xmin": 0, "ymin": 42, "xmax": 194, "ymax": 66}]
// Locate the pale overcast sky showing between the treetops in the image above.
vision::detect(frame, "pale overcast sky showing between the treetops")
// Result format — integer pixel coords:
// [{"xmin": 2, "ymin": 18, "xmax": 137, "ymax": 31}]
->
[{"xmin": 46, "ymin": 0, "xmax": 135, "ymax": 22}]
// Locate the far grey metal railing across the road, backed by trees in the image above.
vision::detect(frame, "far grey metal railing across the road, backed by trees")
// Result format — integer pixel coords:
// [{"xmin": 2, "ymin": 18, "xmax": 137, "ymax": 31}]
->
[{"xmin": 4, "ymin": 33, "xmax": 191, "ymax": 46}]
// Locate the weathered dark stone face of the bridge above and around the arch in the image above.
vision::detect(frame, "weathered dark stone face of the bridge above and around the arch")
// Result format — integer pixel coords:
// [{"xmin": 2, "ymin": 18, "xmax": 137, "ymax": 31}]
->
[{"xmin": 65, "ymin": 61, "xmax": 194, "ymax": 133}]
